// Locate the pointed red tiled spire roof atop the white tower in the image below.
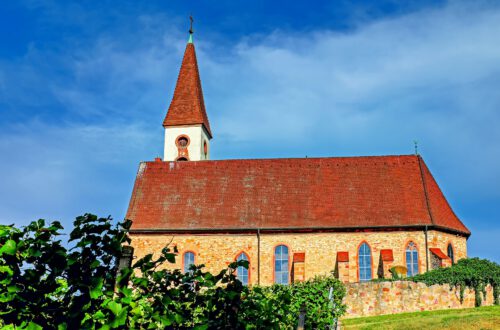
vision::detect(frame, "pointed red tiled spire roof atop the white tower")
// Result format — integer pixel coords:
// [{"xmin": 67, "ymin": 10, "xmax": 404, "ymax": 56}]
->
[{"xmin": 163, "ymin": 43, "xmax": 212, "ymax": 137}]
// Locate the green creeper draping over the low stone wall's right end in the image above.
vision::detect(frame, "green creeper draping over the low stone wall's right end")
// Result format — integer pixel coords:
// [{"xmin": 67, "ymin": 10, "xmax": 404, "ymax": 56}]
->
[{"xmin": 411, "ymin": 258, "xmax": 500, "ymax": 306}]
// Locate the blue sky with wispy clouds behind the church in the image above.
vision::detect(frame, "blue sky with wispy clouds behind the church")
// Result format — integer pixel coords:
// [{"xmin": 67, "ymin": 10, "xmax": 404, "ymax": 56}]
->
[{"xmin": 0, "ymin": 0, "xmax": 500, "ymax": 262}]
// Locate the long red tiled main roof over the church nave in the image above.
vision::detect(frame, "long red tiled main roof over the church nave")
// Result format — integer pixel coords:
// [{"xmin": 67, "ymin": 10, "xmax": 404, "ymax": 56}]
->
[{"xmin": 127, "ymin": 155, "xmax": 470, "ymax": 235}]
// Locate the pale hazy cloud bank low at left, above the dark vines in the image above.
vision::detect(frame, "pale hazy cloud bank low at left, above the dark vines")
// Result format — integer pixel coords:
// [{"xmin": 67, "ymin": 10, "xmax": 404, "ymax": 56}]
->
[{"xmin": 0, "ymin": 122, "xmax": 161, "ymax": 224}]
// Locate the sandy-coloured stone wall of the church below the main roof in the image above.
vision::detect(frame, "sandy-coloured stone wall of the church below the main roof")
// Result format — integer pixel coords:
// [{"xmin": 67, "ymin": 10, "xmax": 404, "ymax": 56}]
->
[{"xmin": 131, "ymin": 231, "xmax": 467, "ymax": 285}]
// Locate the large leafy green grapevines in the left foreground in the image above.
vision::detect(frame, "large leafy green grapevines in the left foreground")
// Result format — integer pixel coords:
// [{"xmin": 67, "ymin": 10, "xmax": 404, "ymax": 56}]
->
[{"xmin": 0, "ymin": 214, "xmax": 345, "ymax": 329}]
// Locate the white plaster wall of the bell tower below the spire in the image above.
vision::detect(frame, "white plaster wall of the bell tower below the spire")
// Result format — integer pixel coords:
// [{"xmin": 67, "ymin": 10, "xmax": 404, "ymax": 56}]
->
[{"xmin": 163, "ymin": 125, "xmax": 210, "ymax": 161}]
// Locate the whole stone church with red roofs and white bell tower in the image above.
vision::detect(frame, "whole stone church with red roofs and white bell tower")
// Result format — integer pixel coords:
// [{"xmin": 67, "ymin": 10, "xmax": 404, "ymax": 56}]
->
[{"xmin": 126, "ymin": 31, "xmax": 470, "ymax": 285}]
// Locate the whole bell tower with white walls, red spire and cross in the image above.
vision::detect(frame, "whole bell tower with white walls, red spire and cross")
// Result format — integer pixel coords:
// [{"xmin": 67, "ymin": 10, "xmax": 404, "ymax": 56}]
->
[{"xmin": 163, "ymin": 17, "xmax": 212, "ymax": 161}]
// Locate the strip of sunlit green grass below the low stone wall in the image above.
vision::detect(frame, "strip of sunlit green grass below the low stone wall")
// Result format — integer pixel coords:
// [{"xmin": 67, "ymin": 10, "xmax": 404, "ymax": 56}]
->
[{"xmin": 342, "ymin": 306, "xmax": 500, "ymax": 330}]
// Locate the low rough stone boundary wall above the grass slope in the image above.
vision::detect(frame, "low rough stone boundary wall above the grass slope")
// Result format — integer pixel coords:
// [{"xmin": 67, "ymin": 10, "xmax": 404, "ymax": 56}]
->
[{"xmin": 344, "ymin": 281, "xmax": 494, "ymax": 318}]
